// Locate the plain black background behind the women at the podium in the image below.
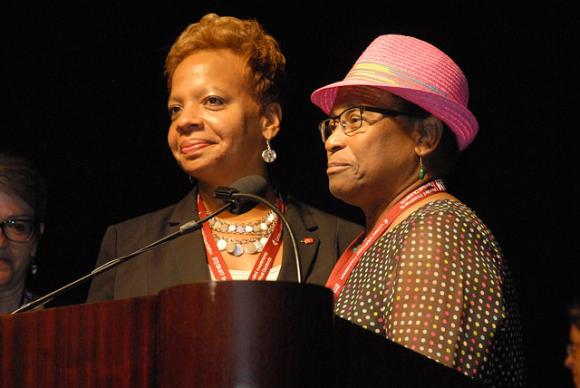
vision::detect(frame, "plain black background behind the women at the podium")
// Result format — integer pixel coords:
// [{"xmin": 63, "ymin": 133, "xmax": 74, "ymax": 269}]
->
[{"xmin": 0, "ymin": 1, "xmax": 580, "ymax": 387}]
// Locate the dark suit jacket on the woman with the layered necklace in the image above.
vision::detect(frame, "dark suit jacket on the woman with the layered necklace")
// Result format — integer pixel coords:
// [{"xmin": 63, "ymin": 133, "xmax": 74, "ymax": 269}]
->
[{"xmin": 87, "ymin": 189, "xmax": 361, "ymax": 302}]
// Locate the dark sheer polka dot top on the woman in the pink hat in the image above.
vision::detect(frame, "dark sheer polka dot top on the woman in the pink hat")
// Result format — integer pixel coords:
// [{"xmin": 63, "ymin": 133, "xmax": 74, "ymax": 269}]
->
[{"xmin": 335, "ymin": 200, "xmax": 526, "ymax": 387}]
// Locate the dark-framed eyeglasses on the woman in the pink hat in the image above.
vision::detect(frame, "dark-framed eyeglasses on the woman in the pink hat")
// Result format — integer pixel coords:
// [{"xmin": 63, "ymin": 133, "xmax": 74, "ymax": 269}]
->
[{"xmin": 318, "ymin": 105, "xmax": 405, "ymax": 143}]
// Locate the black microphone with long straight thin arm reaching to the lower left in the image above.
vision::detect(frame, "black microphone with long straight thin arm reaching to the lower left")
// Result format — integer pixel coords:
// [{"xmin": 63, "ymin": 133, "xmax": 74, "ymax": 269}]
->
[{"xmin": 10, "ymin": 177, "xmax": 267, "ymax": 314}]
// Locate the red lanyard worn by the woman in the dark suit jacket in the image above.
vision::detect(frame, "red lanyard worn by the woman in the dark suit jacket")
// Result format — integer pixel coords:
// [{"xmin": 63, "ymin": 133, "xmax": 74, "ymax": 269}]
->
[{"xmin": 197, "ymin": 194, "xmax": 284, "ymax": 280}]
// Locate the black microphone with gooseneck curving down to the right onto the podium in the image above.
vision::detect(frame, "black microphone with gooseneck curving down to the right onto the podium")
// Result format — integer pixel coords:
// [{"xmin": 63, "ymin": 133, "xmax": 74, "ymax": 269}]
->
[{"xmin": 214, "ymin": 175, "xmax": 302, "ymax": 283}]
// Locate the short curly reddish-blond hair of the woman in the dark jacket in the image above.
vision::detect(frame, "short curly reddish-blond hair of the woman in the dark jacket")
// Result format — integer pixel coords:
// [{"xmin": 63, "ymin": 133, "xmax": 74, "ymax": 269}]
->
[{"xmin": 165, "ymin": 13, "xmax": 286, "ymax": 105}]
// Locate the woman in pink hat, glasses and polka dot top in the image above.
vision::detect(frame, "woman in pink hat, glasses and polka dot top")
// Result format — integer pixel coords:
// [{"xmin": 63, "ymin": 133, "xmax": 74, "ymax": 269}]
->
[{"xmin": 312, "ymin": 35, "xmax": 525, "ymax": 386}]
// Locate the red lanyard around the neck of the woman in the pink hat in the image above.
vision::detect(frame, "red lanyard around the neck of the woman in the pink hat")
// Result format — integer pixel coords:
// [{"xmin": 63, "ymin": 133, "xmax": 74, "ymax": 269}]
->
[{"xmin": 326, "ymin": 180, "xmax": 445, "ymax": 300}]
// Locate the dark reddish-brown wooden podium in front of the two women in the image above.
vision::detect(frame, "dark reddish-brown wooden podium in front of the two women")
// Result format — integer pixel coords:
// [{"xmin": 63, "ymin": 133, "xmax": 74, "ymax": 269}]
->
[{"xmin": 0, "ymin": 281, "xmax": 481, "ymax": 388}]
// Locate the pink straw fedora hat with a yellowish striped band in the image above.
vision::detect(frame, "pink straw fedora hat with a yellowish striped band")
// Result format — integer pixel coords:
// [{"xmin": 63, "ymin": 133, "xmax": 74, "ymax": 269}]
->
[{"xmin": 311, "ymin": 35, "xmax": 479, "ymax": 150}]
